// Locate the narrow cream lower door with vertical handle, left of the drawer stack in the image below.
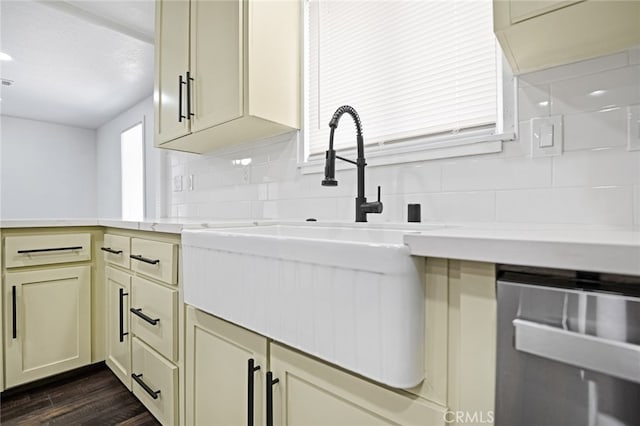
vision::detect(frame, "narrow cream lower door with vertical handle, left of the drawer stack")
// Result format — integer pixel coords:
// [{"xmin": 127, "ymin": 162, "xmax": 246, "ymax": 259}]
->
[{"xmin": 105, "ymin": 266, "xmax": 131, "ymax": 390}]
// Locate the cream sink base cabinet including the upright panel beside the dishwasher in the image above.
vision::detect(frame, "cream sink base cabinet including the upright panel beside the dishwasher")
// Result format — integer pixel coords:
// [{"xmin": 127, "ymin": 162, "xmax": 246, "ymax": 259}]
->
[{"xmin": 185, "ymin": 258, "xmax": 496, "ymax": 426}]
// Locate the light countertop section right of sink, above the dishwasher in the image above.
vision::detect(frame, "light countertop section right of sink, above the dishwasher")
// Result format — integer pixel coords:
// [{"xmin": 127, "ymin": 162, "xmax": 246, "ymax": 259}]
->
[{"xmin": 404, "ymin": 224, "xmax": 640, "ymax": 276}]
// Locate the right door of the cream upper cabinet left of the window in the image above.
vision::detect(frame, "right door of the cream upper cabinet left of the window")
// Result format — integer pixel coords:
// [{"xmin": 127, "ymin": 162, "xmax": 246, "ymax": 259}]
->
[{"xmin": 190, "ymin": 0, "xmax": 244, "ymax": 132}]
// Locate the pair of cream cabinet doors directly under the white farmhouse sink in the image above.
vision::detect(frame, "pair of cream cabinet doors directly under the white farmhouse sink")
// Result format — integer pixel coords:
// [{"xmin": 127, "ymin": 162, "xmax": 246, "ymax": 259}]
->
[{"xmin": 186, "ymin": 306, "xmax": 445, "ymax": 426}]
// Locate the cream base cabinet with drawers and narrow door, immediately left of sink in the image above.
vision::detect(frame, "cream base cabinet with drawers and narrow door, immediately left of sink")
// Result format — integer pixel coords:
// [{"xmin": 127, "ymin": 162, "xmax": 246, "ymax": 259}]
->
[{"xmin": 102, "ymin": 229, "xmax": 184, "ymax": 426}]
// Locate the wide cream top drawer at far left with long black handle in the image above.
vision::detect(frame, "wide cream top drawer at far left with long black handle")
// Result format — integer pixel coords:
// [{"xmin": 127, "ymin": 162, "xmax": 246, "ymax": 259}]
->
[{"xmin": 4, "ymin": 233, "xmax": 91, "ymax": 268}]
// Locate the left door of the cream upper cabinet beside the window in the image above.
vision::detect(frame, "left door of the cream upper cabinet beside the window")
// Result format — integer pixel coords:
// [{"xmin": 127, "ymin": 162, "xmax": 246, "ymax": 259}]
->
[{"xmin": 154, "ymin": 0, "xmax": 189, "ymax": 145}]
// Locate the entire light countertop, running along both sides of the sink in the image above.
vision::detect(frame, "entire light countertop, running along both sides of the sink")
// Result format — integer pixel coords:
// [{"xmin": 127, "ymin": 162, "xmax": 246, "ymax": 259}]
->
[{"xmin": 0, "ymin": 218, "xmax": 640, "ymax": 276}]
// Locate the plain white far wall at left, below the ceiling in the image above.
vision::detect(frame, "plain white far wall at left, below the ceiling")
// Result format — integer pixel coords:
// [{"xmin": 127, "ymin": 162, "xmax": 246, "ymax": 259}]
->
[{"xmin": 0, "ymin": 116, "xmax": 96, "ymax": 219}]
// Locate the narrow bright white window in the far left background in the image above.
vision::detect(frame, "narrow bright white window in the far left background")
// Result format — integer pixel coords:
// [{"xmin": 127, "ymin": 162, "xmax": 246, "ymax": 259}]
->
[{"xmin": 120, "ymin": 123, "xmax": 144, "ymax": 220}]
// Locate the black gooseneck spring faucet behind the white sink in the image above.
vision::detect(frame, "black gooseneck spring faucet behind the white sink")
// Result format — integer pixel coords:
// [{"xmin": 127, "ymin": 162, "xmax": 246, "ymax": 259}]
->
[{"xmin": 322, "ymin": 105, "xmax": 382, "ymax": 222}]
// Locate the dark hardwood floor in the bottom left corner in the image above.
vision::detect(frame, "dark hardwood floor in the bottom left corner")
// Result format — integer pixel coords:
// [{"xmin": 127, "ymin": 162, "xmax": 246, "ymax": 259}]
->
[{"xmin": 0, "ymin": 366, "xmax": 160, "ymax": 426}]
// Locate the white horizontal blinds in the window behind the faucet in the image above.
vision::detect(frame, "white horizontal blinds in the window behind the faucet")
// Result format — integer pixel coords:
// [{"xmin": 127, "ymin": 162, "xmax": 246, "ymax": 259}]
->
[{"xmin": 306, "ymin": 0, "xmax": 497, "ymax": 155}]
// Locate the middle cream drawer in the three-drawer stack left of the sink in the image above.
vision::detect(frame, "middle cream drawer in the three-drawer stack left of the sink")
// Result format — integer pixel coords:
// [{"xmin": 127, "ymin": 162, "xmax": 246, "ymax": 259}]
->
[{"xmin": 131, "ymin": 277, "xmax": 178, "ymax": 361}]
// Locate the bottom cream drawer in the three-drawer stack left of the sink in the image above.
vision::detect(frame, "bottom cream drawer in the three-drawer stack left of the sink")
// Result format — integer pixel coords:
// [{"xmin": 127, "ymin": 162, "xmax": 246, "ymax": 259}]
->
[{"xmin": 131, "ymin": 337, "xmax": 178, "ymax": 425}]
